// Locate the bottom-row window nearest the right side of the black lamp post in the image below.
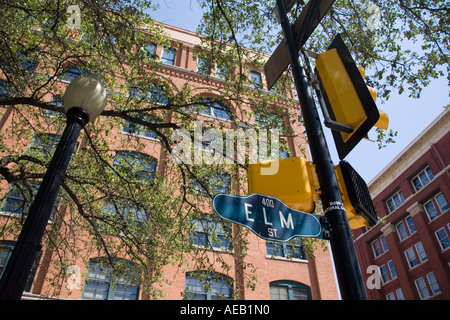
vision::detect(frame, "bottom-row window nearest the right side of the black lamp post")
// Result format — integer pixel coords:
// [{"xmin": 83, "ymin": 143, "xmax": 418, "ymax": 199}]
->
[{"xmin": 82, "ymin": 259, "xmax": 139, "ymax": 300}]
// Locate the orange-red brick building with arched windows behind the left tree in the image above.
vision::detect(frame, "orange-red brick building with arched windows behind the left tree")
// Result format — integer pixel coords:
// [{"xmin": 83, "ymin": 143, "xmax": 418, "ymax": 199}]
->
[{"xmin": 0, "ymin": 22, "xmax": 338, "ymax": 300}]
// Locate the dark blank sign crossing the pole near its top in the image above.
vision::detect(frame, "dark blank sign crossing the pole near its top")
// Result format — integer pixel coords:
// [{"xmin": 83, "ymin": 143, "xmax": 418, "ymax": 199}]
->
[{"xmin": 264, "ymin": 0, "xmax": 335, "ymax": 90}]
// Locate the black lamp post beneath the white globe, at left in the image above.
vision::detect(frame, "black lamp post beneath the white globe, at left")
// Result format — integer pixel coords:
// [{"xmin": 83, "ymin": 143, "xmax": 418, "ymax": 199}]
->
[{"xmin": 0, "ymin": 107, "xmax": 89, "ymax": 300}]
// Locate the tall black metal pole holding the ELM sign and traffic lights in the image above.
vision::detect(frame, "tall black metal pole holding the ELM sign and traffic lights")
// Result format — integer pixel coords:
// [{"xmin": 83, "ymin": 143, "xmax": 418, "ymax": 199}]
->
[{"xmin": 277, "ymin": 0, "xmax": 367, "ymax": 300}]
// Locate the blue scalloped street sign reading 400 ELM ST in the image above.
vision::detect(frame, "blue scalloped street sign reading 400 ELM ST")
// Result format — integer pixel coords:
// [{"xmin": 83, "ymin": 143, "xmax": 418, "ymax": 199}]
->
[{"xmin": 213, "ymin": 193, "xmax": 327, "ymax": 242}]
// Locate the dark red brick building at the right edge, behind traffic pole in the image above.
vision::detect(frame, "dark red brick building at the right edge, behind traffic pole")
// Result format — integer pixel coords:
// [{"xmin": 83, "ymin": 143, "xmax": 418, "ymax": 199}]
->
[{"xmin": 354, "ymin": 110, "xmax": 450, "ymax": 300}]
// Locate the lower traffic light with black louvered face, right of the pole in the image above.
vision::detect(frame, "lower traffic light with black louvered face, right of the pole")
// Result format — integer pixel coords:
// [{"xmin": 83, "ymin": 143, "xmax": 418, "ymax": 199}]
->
[{"xmin": 334, "ymin": 161, "xmax": 378, "ymax": 229}]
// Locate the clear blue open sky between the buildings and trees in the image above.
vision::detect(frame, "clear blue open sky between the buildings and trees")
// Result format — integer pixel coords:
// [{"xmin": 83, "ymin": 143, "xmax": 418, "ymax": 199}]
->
[{"xmin": 150, "ymin": 0, "xmax": 450, "ymax": 184}]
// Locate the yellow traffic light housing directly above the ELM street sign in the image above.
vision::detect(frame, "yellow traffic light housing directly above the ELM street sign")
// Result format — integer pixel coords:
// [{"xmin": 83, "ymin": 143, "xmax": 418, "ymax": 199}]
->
[{"xmin": 248, "ymin": 158, "xmax": 319, "ymax": 213}]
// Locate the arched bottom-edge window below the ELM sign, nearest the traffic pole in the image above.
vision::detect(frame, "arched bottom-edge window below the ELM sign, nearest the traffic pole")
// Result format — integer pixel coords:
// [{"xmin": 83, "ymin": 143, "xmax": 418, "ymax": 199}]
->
[{"xmin": 270, "ymin": 280, "xmax": 312, "ymax": 300}]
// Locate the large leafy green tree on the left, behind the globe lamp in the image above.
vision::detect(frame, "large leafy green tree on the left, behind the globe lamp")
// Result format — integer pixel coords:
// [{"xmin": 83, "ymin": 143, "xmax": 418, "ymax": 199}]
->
[{"xmin": 0, "ymin": 0, "xmax": 295, "ymax": 297}]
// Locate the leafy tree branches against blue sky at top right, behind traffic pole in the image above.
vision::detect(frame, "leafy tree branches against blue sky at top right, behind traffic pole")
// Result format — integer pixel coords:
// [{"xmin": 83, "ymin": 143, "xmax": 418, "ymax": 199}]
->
[{"xmin": 198, "ymin": 0, "xmax": 450, "ymax": 148}]
